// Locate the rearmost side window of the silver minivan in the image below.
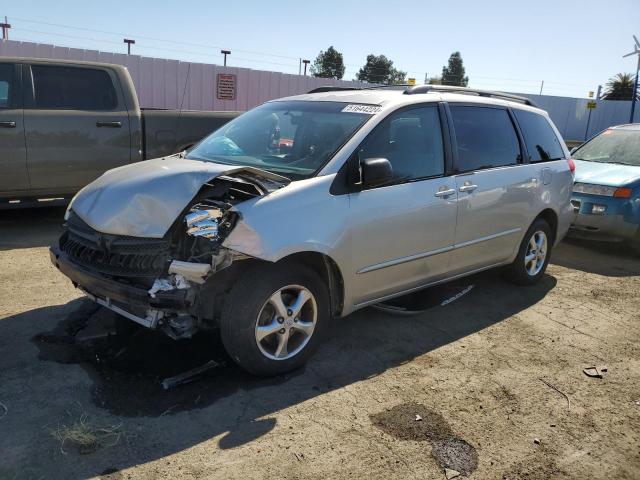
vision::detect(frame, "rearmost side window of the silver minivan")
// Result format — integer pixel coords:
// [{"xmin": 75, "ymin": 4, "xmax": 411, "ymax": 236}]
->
[{"xmin": 513, "ymin": 110, "xmax": 564, "ymax": 162}]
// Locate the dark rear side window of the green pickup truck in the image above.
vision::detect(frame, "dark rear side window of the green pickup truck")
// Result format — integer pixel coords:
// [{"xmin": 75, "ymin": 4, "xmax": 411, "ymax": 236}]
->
[{"xmin": 31, "ymin": 65, "xmax": 118, "ymax": 111}]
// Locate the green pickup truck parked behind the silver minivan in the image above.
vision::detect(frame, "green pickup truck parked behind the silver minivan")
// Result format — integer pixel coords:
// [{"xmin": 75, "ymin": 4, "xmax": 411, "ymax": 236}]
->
[{"xmin": 0, "ymin": 57, "xmax": 238, "ymax": 209}]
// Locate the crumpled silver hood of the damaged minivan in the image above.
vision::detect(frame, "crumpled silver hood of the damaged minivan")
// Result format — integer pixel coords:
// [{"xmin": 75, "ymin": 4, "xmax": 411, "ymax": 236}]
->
[{"xmin": 69, "ymin": 155, "xmax": 289, "ymax": 238}]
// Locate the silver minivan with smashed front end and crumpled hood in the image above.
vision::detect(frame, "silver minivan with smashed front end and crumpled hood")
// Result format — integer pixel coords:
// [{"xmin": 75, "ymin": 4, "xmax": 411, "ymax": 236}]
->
[{"xmin": 51, "ymin": 86, "xmax": 574, "ymax": 375}]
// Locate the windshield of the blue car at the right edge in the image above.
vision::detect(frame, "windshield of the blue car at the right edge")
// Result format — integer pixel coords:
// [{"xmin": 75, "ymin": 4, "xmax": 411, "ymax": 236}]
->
[{"xmin": 572, "ymin": 129, "xmax": 640, "ymax": 166}]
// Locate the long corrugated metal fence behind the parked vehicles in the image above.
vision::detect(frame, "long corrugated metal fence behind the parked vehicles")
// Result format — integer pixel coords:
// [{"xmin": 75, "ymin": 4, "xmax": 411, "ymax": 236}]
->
[{"xmin": 0, "ymin": 40, "xmax": 640, "ymax": 141}]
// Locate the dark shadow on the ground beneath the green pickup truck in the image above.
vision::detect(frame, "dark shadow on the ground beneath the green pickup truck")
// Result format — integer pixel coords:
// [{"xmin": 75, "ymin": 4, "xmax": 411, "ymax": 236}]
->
[{"xmin": 0, "ymin": 207, "xmax": 65, "ymax": 251}]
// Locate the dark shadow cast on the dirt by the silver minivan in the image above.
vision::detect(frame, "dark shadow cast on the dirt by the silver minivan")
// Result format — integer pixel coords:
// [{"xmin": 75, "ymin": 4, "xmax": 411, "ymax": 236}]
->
[{"xmin": 0, "ymin": 271, "xmax": 556, "ymax": 478}]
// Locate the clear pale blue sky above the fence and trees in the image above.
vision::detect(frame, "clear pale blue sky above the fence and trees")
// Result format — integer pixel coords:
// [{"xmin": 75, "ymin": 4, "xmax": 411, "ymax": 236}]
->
[{"xmin": 5, "ymin": 0, "xmax": 640, "ymax": 97}]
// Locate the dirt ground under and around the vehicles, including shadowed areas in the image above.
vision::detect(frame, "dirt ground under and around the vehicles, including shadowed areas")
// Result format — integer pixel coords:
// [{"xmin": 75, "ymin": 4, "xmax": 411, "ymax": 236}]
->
[{"xmin": 0, "ymin": 209, "xmax": 640, "ymax": 480}]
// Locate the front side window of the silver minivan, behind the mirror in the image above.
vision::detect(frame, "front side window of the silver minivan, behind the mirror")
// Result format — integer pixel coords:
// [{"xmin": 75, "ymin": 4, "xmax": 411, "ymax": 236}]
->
[{"xmin": 360, "ymin": 105, "xmax": 444, "ymax": 182}]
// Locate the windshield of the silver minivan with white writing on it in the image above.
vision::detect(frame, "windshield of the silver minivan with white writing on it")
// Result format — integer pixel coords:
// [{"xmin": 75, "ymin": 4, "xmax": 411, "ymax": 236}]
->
[{"xmin": 186, "ymin": 101, "xmax": 371, "ymax": 180}]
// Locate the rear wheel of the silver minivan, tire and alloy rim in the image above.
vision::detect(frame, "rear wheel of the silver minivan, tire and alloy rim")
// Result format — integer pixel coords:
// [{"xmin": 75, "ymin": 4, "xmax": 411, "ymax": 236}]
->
[{"xmin": 505, "ymin": 218, "xmax": 553, "ymax": 286}]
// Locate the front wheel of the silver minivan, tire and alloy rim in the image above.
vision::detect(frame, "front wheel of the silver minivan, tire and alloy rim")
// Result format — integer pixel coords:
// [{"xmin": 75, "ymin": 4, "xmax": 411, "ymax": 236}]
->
[{"xmin": 220, "ymin": 262, "xmax": 330, "ymax": 376}]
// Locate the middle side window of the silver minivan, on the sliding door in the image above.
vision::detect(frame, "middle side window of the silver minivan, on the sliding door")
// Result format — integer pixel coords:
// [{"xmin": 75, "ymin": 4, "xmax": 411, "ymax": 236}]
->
[{"xmin": 451, "ymin": 106, "xmax": 520, "ymax": 172}]
